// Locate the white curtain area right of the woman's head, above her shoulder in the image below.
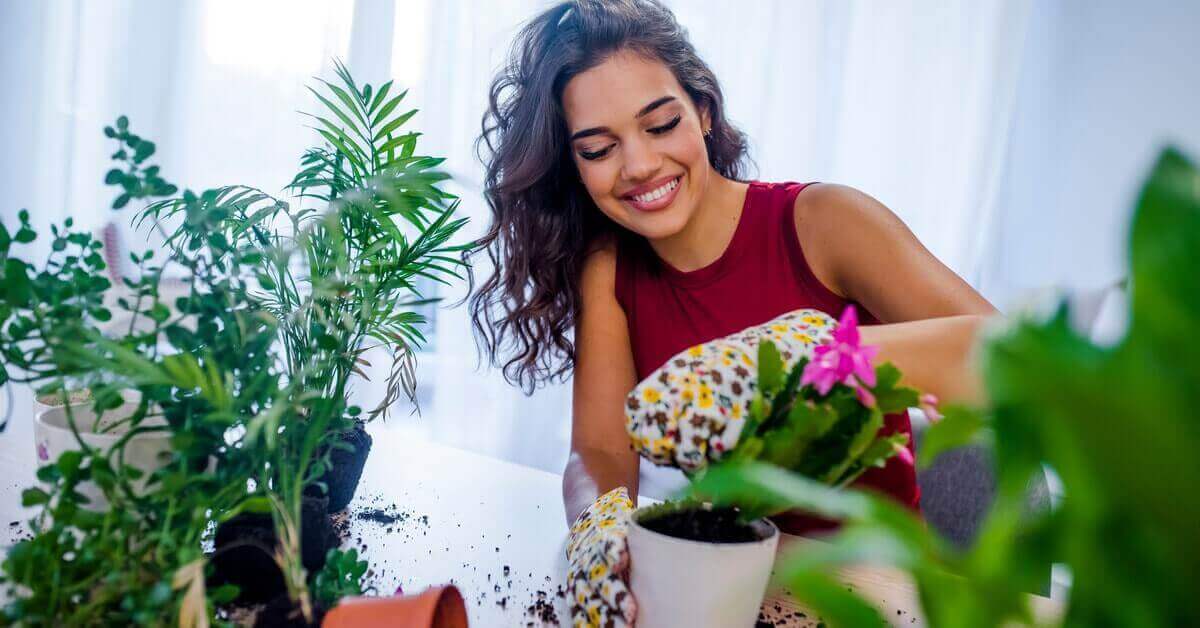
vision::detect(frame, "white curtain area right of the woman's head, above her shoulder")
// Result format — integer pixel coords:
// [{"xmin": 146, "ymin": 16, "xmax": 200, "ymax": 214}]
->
[{"xmin": 673, "ymin": 0, "xmax": 1030, "ymax": 282}]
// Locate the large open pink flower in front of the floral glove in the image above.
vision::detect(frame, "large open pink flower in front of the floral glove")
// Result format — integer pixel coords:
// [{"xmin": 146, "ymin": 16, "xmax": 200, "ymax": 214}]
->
[{"xmin": 800, "ymin": 305, "xmax": 880, "ymax": 407}]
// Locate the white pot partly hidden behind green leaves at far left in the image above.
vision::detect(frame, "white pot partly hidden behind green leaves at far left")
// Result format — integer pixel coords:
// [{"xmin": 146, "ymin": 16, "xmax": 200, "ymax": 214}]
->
[{"xmin": 34, "ymin": 401, "xmax": 172, "ymax": 510}]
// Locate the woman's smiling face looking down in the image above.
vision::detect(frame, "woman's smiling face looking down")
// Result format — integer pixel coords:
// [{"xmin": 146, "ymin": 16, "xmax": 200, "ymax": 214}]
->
[{"xmin": 563, "ymin": 52, "xmax": 715, "ymax": 240}]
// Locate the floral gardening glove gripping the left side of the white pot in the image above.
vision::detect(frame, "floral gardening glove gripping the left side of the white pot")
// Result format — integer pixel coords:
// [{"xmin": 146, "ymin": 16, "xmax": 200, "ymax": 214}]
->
[{"xmin": 566, "ymin": 486, "xmax": 637, "ymax": 628}]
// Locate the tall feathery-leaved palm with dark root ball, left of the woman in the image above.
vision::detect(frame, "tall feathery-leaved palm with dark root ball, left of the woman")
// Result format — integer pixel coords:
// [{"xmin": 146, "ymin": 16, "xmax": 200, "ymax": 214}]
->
[{"xmin": 143, "ymin": 64, "xmax": 470, "ymax": 512}]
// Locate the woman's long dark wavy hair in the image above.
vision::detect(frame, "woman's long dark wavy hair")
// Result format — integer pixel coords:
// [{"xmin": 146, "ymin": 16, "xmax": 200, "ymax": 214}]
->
[{"xmin": 470, "ymin": 0, "xmax": 746, "ymax": 393}]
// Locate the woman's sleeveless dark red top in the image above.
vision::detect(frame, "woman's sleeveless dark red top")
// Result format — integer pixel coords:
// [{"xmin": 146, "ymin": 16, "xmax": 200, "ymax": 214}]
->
[{"xmin": 616, "ymin": 181, "xmax": 920, "ymax": 532}]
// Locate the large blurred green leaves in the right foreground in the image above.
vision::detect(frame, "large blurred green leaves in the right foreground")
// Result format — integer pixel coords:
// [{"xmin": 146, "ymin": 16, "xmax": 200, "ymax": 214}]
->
[{"xmin": 697, "ymin": 149, "xmax": 1200, "ymax": 626}]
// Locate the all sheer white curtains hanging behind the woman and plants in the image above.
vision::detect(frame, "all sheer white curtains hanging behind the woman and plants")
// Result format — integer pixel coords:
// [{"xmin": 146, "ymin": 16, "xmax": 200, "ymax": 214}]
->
[{"xmin": 0, "ymin": 0, "xmax": 1030, "ymax": 471}]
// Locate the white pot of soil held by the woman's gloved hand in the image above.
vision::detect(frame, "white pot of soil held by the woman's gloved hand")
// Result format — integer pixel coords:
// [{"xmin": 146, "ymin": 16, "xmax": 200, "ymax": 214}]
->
[{"xmin": 629, "ymin": 509, "xmax": 779, "ymax": 628}]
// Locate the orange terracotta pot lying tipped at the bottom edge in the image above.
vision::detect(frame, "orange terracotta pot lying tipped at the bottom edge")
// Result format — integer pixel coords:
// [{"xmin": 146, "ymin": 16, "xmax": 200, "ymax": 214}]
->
[{"xmin": 322, "ymin": 585, "xmax": 467, "ymax": 628}]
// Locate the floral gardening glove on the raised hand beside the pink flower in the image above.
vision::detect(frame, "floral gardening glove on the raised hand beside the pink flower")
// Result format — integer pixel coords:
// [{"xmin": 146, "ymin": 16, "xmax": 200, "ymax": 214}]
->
[{"xmin": 625, "ymin": 310, "xmax": 838, "ymax": 472}]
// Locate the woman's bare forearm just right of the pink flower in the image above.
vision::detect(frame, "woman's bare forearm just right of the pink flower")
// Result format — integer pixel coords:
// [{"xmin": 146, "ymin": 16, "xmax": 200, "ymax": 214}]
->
[{"xmin": 860, "ymin": 315, "xmax": 988, "ymax": 403}]
